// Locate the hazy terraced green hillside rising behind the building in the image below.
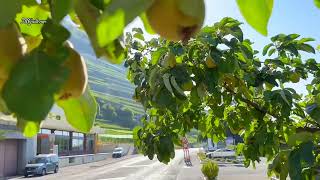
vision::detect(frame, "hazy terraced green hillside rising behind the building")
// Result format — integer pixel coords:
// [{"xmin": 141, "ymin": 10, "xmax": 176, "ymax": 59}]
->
[{"xmin": 63, "ymin": 21, "xmax": 144, "ymax": 128}]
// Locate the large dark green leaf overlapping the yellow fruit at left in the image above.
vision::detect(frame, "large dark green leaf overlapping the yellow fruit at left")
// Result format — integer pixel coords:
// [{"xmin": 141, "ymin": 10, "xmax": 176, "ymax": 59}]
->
[{"xmin": 3, "ymin": 51, "xmax": 68, "ymax": 121}]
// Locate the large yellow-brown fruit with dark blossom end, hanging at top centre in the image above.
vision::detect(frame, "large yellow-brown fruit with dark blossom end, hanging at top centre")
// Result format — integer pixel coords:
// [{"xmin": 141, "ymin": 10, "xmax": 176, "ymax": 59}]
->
[{"xmin": 146, "ymin": 0, "xmax": 205, "ymax": 41}]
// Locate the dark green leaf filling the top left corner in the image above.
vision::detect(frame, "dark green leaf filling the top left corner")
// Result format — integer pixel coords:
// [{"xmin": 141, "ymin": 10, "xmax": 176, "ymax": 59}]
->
[{"xmin": 0, "ymin": 0, "xmax": 22, "ymax": 27}]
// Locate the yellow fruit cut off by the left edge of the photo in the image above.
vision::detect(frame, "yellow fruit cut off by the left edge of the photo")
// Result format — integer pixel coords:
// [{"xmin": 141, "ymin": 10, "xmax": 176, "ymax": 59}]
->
[{"xmin": 0, "ymin": 24, "xmax": 26, "ymax": 91}]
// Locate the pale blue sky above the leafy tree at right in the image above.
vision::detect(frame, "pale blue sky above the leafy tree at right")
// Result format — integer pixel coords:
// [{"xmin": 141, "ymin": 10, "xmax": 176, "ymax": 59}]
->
[{"xmin": 126, "ymin": 0, "xmax": 320, "ymax": 93}]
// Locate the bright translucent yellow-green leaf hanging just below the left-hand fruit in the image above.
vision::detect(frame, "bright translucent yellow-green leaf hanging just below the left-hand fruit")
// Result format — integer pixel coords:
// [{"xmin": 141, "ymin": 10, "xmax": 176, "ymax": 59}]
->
[{"xmin": 57, "ymin": 88, "xmax": 98, "ymax": 133}]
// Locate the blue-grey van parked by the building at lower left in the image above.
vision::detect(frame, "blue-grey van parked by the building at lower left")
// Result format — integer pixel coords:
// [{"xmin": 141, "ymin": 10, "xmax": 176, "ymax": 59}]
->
[{"xmin": 24, "ymin": 154, "xmax": 59, "ymax": 177}]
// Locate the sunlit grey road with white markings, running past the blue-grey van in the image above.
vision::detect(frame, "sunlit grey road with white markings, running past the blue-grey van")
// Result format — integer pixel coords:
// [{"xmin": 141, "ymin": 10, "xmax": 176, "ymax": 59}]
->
[{"xmin": 14, "ymin": 150, "xmax": 203, "ymax": 180}]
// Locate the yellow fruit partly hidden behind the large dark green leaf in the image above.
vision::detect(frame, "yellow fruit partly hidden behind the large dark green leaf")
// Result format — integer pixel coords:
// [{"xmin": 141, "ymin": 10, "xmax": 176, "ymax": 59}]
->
[{"xmin": 58, "ymin": 45, "xmax": 88, "ymax": 100}]
